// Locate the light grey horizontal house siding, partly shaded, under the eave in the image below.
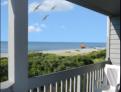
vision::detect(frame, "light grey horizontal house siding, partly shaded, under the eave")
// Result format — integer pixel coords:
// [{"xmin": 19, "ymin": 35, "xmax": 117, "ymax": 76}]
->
[{"xmin": 109, "ymin": 17, "xmax": 120, "ymax": 65}]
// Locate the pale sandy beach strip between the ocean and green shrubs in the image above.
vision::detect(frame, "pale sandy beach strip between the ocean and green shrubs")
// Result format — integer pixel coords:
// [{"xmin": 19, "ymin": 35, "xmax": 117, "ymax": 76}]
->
[{"xmin": 0, "ymin": 48, "xmax": 105, "ymax": 57}]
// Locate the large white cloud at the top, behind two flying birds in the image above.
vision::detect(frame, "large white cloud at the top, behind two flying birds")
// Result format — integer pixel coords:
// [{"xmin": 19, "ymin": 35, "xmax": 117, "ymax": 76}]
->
[{"xmin": 29, "ymin": 0, "xmax": 74, "ymax": 12}]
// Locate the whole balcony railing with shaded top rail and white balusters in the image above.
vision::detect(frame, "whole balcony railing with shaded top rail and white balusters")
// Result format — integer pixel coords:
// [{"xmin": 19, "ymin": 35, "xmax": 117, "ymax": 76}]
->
[{"xmin": 28, "ymin": 62, "xmax": 108, "ymax": 92}]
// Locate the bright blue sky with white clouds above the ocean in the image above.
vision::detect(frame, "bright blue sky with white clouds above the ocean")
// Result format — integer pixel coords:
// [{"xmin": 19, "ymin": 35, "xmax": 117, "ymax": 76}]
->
[{"xmin": 1, "ymin": 0, "xmax": 107, "ymax": 42}]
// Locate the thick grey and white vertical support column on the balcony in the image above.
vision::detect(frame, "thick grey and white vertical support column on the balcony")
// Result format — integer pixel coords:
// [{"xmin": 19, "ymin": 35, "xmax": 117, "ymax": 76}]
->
[{"xmin": 8, "ymin": 0, "xmax": 28, "ymax": 92}]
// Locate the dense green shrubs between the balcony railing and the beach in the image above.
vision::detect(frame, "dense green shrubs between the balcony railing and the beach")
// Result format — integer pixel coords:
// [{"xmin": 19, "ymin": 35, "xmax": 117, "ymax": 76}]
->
[{"xmin": 0, "ymin": 50, "xmax": 106, "ymax": 81}]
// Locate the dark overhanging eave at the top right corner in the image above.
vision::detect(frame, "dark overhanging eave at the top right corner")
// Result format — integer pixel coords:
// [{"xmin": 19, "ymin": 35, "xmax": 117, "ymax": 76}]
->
[{"xmin": 67, "ymin": 0, "xmax": 120, "ymax": 16}]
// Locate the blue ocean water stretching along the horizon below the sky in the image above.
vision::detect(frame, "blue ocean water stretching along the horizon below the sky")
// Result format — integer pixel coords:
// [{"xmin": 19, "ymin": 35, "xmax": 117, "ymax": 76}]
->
[{"xmin": 0, "ymin": 42, "xmax": 106, "ymax": 53}]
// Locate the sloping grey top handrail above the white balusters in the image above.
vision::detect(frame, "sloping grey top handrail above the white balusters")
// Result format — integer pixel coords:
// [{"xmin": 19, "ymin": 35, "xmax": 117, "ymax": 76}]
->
[{"xmin": 28, "ymin": 61, "xmax": 110, "ymax": 89}]
